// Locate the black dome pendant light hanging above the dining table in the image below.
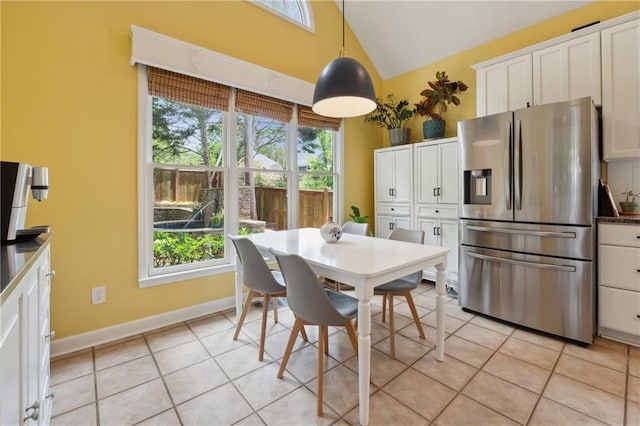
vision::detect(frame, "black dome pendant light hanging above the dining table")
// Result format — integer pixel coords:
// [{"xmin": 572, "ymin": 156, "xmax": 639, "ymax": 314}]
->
[{"xmin": 312, "ymin": 0, "xmax": 376, "ymax": 118}]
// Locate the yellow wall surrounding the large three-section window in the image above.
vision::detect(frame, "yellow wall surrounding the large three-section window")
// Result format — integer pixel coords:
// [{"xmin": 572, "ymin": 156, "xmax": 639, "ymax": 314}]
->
[{"xmin": 0, "ymin": 1, "xmax": 382, "ymax": 337}]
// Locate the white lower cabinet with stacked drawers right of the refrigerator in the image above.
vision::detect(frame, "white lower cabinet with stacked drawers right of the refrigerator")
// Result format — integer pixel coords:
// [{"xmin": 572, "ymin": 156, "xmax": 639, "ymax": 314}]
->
[{"xmin": 598, "ymin": 223, "xmax": 640, "ymax": 346}]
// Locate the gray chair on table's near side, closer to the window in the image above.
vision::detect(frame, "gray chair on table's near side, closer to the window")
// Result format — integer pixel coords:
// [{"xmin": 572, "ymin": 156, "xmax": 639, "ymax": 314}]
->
[{"xmin": 228, "ymin": 235, "xmax": 307, "ymax": 361}]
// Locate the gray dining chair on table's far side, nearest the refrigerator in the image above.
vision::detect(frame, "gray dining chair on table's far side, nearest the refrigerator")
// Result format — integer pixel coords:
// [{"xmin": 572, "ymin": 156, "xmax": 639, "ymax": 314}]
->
[{"xmin": 373, "ymin": 228, "xmax": 425, "ymax": 359}]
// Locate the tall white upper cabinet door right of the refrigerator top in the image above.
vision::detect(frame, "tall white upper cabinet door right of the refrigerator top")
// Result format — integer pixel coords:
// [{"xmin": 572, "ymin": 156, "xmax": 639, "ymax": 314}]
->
[{"xmin": 602, "ymin": 20, "xmax": 640, "ymax": 161}]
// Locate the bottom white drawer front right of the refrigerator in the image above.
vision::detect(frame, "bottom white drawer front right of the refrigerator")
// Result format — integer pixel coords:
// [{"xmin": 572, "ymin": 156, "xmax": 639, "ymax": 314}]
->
[{"xmin": 598, "ymin": 287, "xmax": 640, "ymax": 336}]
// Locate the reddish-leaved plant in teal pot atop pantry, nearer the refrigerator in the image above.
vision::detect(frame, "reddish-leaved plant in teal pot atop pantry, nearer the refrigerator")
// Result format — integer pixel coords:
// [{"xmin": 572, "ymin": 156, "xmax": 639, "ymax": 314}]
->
[{"xmin": 414, "ymin": 71, "xmax": 468, "ymax": 139}]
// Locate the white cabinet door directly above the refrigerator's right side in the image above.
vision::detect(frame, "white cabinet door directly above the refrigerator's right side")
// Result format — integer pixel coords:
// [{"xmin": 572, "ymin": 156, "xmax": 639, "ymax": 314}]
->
[{"xmin": 533, "ymin": 33, "xmax": 602, "ymax": 105}]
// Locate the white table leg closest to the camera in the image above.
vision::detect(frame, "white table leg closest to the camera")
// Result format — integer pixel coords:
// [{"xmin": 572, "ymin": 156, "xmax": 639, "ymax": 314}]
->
[{"xmin": 356, "ymin": 288, "xmax": 373, "ymax": 425}]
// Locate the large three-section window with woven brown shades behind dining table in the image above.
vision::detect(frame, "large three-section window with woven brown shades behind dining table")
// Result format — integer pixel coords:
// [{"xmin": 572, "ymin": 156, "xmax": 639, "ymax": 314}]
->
[{"xmin": 139, "ymin": 66, "xmax": 340, "ymax": 287}]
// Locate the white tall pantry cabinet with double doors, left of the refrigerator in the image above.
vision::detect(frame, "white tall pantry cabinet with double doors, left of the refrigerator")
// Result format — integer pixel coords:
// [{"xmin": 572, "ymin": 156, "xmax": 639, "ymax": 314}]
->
[{"xmin": 374, "ymin": 138, "xmax": 459, "ymax": 283}]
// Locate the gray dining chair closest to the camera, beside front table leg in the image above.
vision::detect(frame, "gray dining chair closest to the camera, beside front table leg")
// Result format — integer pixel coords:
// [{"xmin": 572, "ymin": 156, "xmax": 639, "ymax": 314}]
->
[{"xmin": 272, "ymin": 250, "xmax": 358, "ymax": 416}]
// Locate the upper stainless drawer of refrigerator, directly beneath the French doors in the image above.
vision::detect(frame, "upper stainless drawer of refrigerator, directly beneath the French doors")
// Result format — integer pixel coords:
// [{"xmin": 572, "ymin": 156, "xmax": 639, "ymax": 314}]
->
[{"xmin": 460, "ymin": 219, "xmax": 595, "ymax": 260}]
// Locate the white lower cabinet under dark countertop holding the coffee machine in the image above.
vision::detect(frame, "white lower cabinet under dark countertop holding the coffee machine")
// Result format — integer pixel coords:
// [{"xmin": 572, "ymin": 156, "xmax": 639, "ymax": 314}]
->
[{"xmin": 0, "ymin": 243, "xmax": 53, "ymax": 426}]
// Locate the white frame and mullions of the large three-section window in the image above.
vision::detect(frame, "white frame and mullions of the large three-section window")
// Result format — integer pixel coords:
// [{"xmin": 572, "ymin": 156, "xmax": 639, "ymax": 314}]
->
[{"xmin": 137, "ymin": 58, "xmax": 344, "ymax": 288}]
